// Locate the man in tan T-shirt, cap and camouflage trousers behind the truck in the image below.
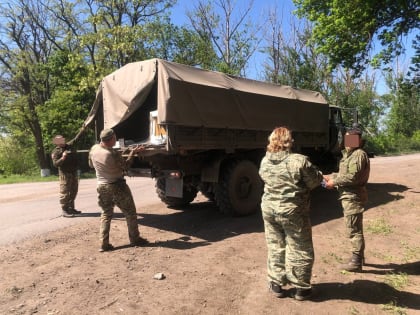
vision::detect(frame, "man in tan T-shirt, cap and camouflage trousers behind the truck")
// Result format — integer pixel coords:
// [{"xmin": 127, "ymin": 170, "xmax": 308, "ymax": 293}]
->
[{"xmin": 89, "ymin": 129, "xmax": 147, "ymax": 252}]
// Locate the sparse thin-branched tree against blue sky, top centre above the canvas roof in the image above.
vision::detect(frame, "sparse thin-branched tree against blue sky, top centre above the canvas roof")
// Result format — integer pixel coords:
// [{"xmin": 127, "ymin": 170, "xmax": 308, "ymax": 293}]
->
[{"xmin": 187, "ymin": 0, "xmax": 259, "ymax": 76}]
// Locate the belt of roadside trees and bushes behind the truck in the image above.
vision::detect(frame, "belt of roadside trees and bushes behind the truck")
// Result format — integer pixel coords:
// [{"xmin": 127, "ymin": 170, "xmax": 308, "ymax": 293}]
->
[{"xmin": 0, "ymin": 0, "xmax": 420, "ymax": 180}]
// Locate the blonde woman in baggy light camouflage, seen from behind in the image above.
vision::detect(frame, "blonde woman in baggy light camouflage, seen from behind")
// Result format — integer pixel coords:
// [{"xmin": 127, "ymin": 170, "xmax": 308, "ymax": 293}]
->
[{"xmin": 259, "ymin": 127, "xmax": 323, "ymax": 301}]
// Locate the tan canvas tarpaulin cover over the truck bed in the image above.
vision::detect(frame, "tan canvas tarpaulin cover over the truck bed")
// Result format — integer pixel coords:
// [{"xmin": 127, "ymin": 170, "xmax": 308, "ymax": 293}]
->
[{"xmin": 84, "ymin": 59, "xmax": 328, "ymax": 133}]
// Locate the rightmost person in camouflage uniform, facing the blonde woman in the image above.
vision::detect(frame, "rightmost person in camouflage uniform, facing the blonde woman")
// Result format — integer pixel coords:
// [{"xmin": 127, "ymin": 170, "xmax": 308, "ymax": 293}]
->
[{"xmin": 325, "ymin": 128, "xmax": 370, "ymax": 272}]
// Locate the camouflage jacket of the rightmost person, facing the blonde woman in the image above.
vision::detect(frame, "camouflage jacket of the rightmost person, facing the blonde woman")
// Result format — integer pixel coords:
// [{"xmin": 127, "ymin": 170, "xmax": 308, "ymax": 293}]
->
[{"xmin": 331, "ymin": 148, "xmax": 370, "ymax": 202}]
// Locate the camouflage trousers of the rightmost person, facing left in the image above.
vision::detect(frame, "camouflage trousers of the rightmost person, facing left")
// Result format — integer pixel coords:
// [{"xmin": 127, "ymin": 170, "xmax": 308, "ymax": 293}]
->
[{"xmin": 341, "ymin": 199, "xmax": 365, "ymax": 257}]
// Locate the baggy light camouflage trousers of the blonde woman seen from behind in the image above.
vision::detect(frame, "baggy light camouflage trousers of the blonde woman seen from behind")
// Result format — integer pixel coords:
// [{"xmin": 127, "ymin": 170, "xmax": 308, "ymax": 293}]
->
[{"xmin": 262, "ymin": 206, "xmax": 315, "ymax": 289}]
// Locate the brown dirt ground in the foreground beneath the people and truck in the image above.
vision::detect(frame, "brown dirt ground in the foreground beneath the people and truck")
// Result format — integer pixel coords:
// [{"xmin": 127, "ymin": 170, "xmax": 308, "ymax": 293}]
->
[{"xmin": 0, "ymin": 154, "xmax": 420, "ymax": 315}]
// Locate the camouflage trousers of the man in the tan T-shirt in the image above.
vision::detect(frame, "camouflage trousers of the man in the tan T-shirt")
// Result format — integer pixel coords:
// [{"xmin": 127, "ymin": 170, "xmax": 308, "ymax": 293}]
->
[{"xmin": 97, "ymin": 181, "xmax": 140, "ymax": 246}]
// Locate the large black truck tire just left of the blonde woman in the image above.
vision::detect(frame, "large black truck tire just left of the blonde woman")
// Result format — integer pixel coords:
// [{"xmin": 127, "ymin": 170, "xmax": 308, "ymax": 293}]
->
[{"xmin": 215, "ymin": 160, "xmax": 263, "ymax": 216}]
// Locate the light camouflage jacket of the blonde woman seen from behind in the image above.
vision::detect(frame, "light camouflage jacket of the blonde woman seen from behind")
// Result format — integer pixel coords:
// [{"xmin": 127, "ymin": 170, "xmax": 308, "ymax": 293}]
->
[{"xmin": 259, "ymin": 151, "xmax": 322, "ymax": 212}]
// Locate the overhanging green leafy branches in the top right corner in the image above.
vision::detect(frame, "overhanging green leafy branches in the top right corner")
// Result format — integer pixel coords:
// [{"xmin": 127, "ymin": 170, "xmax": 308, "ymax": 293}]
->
[{"xmin": 293, "ymin": 0, "xmax": 420, "ymax": 75}]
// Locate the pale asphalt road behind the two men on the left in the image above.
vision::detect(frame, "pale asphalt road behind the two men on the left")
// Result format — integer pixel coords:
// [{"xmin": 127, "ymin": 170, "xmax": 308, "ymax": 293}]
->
[{"xmin": 0, "ymin": 178, "xmax": 159, "ymax": 245}]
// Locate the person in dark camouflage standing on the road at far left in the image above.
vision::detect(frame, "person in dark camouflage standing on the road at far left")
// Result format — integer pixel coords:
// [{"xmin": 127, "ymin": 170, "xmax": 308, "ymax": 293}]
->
[{"xmin": 51, "ymin": 135, "xmax": 81, "ymax": 217}]
